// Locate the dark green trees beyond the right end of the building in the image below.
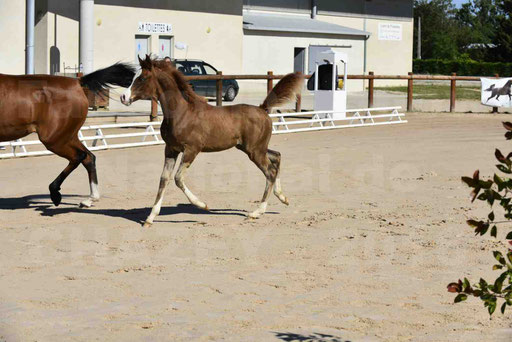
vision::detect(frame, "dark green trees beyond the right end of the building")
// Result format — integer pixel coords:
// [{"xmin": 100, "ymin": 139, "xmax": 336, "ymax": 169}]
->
[{"xmin": 414, "ymin": 0, "xmax": 512, "ymax": 62}]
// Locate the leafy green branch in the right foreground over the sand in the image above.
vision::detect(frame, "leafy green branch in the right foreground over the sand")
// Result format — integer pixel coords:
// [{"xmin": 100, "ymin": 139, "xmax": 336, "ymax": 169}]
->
[{"xmin": 448, "ymin": 122, "xmax": 512, "ymax": 315}]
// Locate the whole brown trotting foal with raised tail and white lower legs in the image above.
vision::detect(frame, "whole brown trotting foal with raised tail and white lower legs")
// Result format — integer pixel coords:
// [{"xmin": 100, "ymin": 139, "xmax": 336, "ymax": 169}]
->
[{"xmin": 121, "ymin": 56, "xmax": 304, "ymax": 227}]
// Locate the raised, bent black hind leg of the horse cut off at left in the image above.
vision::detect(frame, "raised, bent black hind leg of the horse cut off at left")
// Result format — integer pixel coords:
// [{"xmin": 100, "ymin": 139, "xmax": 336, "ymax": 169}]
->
[{"xmin": 46, "ymin": 139, "xmax": 87, "ymax": 206}]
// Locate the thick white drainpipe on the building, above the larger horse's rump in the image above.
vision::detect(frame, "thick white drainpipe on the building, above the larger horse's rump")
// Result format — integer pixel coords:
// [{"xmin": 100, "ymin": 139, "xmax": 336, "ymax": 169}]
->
[{"xmin": 80, "ymin": 0, "xmax": 94, "ymax": 74}]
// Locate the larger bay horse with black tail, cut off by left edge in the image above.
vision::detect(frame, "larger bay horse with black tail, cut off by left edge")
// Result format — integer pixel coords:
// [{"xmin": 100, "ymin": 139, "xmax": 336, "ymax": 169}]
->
[{"xmin": 0, "ymin": 63, "xmax": 135, "ymax": 207}]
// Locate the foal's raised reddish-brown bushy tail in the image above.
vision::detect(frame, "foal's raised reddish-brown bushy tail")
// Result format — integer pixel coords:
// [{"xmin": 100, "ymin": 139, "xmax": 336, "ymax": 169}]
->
[{"xmin": 260, "ymin": 72, "xmax": 304, "ymax": 112}]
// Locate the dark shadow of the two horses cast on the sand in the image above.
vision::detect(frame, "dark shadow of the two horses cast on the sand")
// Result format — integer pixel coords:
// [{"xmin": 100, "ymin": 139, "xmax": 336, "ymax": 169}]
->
[{"xmin": 0, "ymin": 195, "xmax": 275, "ymax": 224}]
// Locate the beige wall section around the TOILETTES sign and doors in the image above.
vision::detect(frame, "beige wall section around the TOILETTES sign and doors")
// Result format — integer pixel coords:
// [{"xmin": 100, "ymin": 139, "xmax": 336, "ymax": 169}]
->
[{"xmin": 94, "ymin": 5, "xmax": 243, "ymax": 73}]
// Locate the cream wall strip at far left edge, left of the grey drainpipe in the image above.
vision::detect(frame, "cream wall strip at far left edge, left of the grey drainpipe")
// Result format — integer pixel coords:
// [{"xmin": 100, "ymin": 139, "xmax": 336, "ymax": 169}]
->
[{"xmin": 0, "ymin": 1, "xmax": 25, "ymax": 74}]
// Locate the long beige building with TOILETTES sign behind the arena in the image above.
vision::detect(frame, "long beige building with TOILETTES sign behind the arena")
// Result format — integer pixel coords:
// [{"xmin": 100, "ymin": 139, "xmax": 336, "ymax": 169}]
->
[{"xmin": 0, "ymin": 0, "xmax": 413, "ymax": 90}]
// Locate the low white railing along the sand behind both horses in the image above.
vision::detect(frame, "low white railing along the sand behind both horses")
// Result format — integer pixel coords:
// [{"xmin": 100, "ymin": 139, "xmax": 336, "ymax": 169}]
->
[{"xmin": 0, "ymin": 107, "xmax": 407, "ymax": 159}]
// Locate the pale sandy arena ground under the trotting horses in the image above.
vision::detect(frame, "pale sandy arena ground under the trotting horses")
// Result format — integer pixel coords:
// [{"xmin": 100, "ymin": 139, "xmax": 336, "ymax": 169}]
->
[{"xmin": 0, "ymin": 114, "xmax": 512, "ymax": 342}]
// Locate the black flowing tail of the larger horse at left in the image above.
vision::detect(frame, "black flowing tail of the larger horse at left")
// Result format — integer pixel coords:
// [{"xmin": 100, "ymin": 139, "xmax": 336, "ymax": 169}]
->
[{"xmin": 80, "ymin": 63, "xmax": 135, "ymax": 93}]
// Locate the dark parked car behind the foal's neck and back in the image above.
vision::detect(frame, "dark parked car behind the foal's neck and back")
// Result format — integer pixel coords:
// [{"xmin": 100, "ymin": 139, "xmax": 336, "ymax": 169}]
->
[{"xmin": 173, "ymin": 59, "xmax": 239, "ymax": 101}]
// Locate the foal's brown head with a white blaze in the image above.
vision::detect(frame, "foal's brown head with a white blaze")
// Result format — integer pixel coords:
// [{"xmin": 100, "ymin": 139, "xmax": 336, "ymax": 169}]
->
[{"xmin": 121, "ymin": 55, "xmax": 158, "ymax": 106}]
